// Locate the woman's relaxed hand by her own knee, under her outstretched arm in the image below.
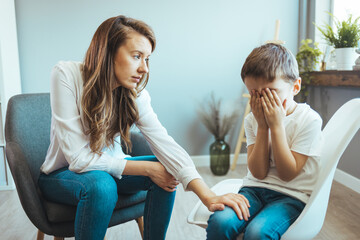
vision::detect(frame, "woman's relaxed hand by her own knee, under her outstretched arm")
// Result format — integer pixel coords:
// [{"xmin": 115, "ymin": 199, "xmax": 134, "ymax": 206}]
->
[{"xmin": 148, "ymin": 162, "xmax": 179, "ymax": 192}]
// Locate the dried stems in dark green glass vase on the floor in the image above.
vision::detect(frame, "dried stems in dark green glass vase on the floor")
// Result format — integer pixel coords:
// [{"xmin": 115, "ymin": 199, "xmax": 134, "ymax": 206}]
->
[{"xmin": 198, "ymin": 93, "xmax": 238, "ymax": 176}]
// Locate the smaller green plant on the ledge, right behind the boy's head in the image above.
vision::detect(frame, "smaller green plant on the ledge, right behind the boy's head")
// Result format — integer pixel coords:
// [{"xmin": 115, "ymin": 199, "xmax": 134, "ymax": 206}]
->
[{"xmin": 296, "ymin": 39, "xmax": 323, "ymax": 102}]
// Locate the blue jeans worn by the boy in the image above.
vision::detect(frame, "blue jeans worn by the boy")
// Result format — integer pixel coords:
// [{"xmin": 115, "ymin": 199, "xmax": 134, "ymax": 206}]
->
[{"xmin": 206, "ymin": 187, "xmax": 305, "ymax": 240}]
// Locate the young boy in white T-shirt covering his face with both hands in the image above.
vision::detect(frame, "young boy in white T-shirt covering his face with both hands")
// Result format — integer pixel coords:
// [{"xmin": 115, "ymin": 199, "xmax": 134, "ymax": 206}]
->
[{"xmin": 206, "ymin": 44, "xmax": 322, "ymax": 240}]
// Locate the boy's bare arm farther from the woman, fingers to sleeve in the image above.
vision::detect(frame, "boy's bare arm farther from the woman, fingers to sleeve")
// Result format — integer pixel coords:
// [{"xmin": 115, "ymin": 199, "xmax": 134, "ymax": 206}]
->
[{"xmin": 262, "ymin": 89, "xmax": 308, "ymax": 181}]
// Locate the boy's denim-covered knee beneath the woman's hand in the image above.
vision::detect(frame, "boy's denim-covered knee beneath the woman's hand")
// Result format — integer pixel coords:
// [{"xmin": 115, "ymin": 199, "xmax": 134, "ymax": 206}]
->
[{"xmin": 206, "ymin": 207, "xmax": 242, "ymax": 240}]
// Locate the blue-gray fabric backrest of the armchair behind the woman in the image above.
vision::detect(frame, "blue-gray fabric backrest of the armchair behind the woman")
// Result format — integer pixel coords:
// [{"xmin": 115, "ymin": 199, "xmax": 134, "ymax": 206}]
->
[{"xmin": 5, "ymin": 93, "xmax": 51, "ymax": 186}]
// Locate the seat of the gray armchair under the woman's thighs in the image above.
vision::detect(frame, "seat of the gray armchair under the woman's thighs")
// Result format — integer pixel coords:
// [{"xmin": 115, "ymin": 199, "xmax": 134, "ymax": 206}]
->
[{"xmin": 43, "ymin": 191, "xmax": 147, "ymax": 223}]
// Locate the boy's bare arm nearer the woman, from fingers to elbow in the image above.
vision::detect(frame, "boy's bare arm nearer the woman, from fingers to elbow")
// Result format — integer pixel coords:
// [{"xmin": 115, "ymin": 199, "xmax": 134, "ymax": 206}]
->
[{"xmin": 247, "ymin": 91, "xmax": 270, "ymax": 179}]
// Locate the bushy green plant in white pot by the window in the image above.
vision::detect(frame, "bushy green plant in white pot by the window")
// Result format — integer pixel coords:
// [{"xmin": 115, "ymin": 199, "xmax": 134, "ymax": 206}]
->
[{"xmin": 317, "ymin": 13, "xmax": 360, "ymax": 70}]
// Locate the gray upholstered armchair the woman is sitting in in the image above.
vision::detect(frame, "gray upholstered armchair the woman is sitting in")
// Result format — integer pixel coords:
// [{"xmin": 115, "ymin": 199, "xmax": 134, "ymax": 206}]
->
[{"xmin": 5, "ymin": 93, "xmax": 152, "ymax": 239}]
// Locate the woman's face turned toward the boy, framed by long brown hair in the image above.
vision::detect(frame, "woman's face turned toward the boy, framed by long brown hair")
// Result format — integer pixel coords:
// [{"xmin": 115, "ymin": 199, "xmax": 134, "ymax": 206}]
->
[{"xmin": 113, "ymin": 32, "xmax": 152, "ymax": 89}]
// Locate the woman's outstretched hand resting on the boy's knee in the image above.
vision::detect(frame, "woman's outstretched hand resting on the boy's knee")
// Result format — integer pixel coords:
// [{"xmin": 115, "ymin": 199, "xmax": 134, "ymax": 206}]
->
[{"xmin": 208, "ymin": 193, "xmax": 250, "ymax": 221}]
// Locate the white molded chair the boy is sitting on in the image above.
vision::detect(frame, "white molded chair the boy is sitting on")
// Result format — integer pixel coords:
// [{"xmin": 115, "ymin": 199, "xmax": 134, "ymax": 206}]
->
[{"xmin": 188, "ymin": 98, "xmax": 360, "ymax": 240}]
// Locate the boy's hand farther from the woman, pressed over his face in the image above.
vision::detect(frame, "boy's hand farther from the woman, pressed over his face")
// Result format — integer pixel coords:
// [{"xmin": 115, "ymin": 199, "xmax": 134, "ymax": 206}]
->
[{"xmin": 261, "ymin": 88, "xmax": 286, "ymax": 129}]
